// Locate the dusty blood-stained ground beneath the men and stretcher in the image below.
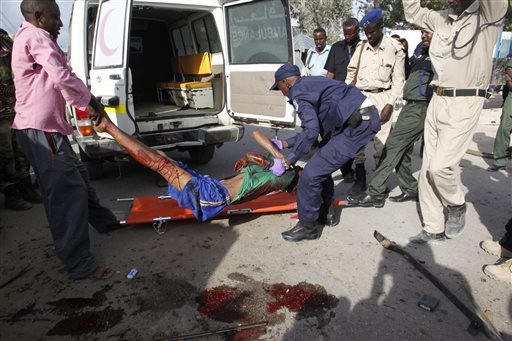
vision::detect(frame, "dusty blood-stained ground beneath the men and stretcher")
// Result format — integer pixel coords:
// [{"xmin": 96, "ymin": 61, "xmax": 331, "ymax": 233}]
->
[{"xmin": 0, "ymin": 112, "xmax": 512, "ymax": 340}]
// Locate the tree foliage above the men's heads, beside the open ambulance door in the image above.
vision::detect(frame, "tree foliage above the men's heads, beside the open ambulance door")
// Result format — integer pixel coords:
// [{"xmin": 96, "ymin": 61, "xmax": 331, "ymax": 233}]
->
[{"xmin": 290, "ymin": 0, "xmax": 352, "ymax": 44}]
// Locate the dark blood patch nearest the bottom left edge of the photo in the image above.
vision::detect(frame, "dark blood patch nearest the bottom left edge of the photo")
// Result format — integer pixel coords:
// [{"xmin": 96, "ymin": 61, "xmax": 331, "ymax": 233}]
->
[{"xmin": 46, "ymin": 307, "xmax": 124, "ymax": 336}]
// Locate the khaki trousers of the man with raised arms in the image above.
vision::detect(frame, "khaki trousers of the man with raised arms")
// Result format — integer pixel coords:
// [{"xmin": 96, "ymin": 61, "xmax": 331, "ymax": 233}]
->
[{"xmin": 418, "ymin": 94, "xmax": 484, "ymax": 233}]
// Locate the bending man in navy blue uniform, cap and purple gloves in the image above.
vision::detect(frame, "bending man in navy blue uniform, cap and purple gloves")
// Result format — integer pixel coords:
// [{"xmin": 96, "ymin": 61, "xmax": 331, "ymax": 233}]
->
[{"xmin": 270, "ymin": 64, "xmax": 380, "ymax": 241}]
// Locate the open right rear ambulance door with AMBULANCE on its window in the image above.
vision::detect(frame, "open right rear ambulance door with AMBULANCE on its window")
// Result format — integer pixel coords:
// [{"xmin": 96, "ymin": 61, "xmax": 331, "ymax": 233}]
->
[{"xmin": 223, "ymin": 0, "xmax": 295, "ymax": 127}]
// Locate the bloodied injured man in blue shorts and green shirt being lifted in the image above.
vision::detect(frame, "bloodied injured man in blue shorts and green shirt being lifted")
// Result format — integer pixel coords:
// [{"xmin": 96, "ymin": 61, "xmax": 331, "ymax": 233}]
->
[{"xmin": 91, "ymin": 107, "xmax": 320, "ymax": 221}]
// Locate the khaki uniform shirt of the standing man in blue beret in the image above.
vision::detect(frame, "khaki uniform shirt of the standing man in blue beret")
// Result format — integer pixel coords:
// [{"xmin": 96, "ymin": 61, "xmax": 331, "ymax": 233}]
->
[{"xmin": 346, "ymin": 36, "xmax": 405, "ymax": 105}]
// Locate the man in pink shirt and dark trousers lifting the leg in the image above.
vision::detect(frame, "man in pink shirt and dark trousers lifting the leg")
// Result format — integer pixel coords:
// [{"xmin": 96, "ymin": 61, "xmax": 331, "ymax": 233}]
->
[{"xmin": 12, "ymin": 0, "xmax": 117, "ymax": 279}]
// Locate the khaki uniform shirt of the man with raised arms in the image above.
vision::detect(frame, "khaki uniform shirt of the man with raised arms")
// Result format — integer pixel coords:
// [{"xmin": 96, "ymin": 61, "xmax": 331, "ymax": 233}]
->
[{"xmin": 403, "ymin": 0, "xmax": 507, "ymax": 89}]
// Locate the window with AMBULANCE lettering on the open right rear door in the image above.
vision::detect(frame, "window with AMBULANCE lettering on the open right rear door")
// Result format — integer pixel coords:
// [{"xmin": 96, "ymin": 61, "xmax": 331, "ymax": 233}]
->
[{"xmin": 226, "ymin": 0, "xmax": 291, "ymax": 64}]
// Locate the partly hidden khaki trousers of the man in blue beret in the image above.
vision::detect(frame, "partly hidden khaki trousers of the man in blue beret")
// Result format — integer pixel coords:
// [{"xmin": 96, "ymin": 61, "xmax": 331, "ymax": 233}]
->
[{"xmin": 354, "ymin": 90, "xmax": 393, "ymax": 165}]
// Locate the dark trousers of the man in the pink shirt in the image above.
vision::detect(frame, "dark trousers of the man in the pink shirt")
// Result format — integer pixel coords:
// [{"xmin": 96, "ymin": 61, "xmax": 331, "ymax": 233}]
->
[{"xmin": 16, "ymin": 129, "xmax": 116, "ymax": 279}]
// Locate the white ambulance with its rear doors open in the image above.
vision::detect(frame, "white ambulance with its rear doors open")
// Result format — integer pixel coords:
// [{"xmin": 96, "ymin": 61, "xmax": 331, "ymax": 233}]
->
[{"xmin": 68, "ymin": 0, "xmax": 295, "ymax": 178}]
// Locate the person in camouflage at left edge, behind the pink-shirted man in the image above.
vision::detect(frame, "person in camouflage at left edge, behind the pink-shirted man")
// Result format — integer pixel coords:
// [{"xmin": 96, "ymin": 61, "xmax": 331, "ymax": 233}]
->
[{"xmin": 0, "ymin": 29, "xmax": 42, "ymax": 211}]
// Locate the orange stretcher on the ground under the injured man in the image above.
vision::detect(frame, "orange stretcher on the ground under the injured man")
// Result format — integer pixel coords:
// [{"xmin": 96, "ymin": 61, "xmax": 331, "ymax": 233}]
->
[{"xmin": 121, "ymin": 192, "xmax": 344, "ymax": 225}]
